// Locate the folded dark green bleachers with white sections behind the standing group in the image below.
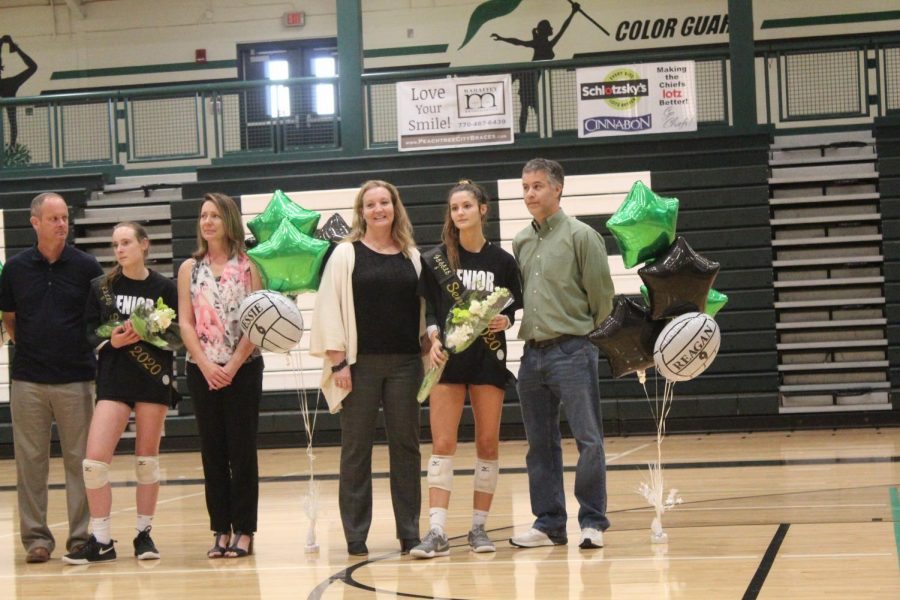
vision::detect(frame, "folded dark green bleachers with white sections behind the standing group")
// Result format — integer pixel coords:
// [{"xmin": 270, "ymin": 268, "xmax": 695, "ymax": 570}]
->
[{"xmin": 0, "ymin": 130, "xmax": 900, "ymax": 451}]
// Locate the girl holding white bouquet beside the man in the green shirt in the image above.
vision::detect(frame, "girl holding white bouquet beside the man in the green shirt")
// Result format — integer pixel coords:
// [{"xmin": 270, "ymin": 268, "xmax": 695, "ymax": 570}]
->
[{"xmin": 410, "ymin": 180, "xmax": 522, "ymax": 558}]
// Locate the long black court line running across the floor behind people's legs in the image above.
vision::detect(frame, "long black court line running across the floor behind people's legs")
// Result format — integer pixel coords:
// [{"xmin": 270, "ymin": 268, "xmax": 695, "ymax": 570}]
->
[{"xmin": 0, "ymin": 456, "xmax": 900, "ymax": 492}]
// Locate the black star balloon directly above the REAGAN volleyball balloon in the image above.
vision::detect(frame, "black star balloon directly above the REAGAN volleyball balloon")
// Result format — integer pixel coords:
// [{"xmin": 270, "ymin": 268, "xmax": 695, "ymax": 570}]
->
[{"xmin": 638, "ymin": 235, "xmax": 719, "ymax": 319}]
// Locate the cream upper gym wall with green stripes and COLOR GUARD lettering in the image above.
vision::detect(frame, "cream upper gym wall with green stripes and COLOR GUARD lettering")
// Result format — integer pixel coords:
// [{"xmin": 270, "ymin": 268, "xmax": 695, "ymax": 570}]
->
[{"xmin": 0, "ymin": 0, "xmax": 897, "ymax": 96}]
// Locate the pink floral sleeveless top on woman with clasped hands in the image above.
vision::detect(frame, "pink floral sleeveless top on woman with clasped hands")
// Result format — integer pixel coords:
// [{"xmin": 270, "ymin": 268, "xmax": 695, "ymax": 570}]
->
[{"xmin": 187, "ymin": 253, "xmax": 252, "ymax": 365}]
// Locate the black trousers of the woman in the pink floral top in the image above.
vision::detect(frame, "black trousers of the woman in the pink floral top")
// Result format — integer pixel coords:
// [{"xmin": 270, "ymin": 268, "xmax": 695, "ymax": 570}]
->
[{"xmin": 187, "ymin": 358, "xmax": 263, "ymax": 533}]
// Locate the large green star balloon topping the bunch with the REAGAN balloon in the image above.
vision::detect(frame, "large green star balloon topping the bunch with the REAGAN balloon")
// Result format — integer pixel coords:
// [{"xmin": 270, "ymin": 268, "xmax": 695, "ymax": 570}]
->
[{"xmin": 606, "ymin": 181, "xmax": 678, "ymax": 269}]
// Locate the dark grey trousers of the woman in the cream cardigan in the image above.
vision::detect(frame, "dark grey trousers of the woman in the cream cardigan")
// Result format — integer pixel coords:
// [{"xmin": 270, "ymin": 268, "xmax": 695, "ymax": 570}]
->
[{"xmin": 339, "ymin": 354, "xmax": 422, "ymax": 542}]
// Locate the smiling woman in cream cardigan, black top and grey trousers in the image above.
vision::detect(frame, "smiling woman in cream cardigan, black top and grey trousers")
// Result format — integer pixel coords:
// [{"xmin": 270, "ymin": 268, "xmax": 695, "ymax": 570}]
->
[{"xmin": 310, "ymin": 181, "xmax": 425, "ymax": 556}]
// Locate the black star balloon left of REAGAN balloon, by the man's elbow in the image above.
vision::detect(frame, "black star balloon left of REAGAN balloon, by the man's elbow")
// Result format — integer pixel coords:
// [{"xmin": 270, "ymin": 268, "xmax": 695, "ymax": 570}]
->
[{"xmin": 588, "ymin": 296, "xmax": 666, "ymax": 378}]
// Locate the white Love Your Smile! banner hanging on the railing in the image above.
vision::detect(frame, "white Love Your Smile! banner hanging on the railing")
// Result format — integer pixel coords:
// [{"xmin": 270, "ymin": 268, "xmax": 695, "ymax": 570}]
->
[{"xmin": 397, "ymin": 74, "xmax": 513, "ymax": 152}]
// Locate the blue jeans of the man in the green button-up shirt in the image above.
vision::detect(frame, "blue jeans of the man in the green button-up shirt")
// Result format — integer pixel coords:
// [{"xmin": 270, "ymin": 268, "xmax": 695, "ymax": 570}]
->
[{"xmin": 517, "ymin": 338, "xmax": 609, "ymax": 536}]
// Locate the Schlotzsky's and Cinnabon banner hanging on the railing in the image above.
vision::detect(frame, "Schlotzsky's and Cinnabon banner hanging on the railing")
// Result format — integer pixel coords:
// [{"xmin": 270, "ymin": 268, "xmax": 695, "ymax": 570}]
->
[{"xmin": 576, "ymin": 61, "xmax": 697, "ymax": 138}]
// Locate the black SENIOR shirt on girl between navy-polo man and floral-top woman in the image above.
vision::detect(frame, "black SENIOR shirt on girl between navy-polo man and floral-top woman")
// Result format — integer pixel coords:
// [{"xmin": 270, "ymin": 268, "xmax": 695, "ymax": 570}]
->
[{"xmin": 85, "ymin": 271, "xmax": 178, "ymax": 406}]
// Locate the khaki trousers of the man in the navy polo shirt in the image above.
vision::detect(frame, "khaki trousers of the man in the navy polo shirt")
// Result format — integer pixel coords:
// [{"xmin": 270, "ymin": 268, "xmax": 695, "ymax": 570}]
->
[{"xmin": 10, "ymin": 380, "xmax": 94, "ymax": 553}]
